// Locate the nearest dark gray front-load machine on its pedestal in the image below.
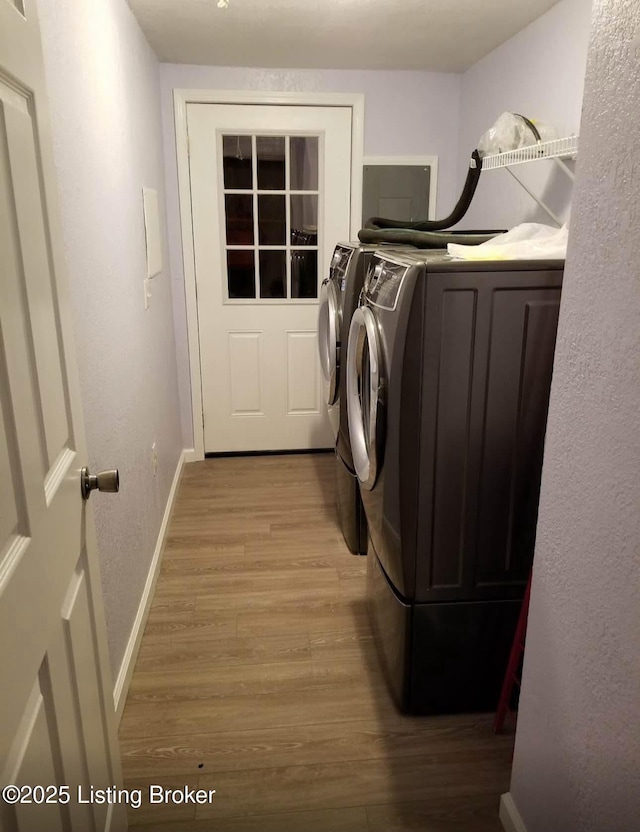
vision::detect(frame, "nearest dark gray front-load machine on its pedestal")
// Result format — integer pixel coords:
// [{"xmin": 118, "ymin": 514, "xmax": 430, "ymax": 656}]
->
[{"xmin": 347, "ymin": 251, "xmax": 564, "ymax": 713}]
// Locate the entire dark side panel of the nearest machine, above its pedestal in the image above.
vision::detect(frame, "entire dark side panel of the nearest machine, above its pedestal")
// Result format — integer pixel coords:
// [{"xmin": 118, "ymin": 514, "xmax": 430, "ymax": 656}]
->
[{"xmin": 415, "ymin": 269, "xmax": 562, "ymax": 602}]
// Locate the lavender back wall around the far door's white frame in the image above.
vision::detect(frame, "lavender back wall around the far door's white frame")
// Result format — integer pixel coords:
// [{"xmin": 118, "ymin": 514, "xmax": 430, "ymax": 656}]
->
[{"xmin": 160, "ymin": 64, "xmax": 460, "ymax": 444}]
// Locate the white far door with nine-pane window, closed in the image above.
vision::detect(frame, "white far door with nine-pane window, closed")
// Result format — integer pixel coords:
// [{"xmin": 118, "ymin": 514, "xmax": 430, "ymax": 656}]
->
[{"xmin": 187, "ymin": 104, "xmax": 352, "ymax": 452}]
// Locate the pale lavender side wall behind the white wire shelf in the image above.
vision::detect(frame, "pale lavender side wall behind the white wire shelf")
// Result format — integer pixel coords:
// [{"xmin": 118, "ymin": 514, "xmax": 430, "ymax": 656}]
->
[{"xmin": 458, "ymin": 0, "xmax": 591, "ymax": 228}]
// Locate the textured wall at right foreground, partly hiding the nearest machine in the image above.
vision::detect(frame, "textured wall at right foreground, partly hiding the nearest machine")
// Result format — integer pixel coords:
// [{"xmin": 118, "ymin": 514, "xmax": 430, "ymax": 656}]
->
[{"xmin": 511, "ymin": 0, "xmax": 640, "ymax": 832}]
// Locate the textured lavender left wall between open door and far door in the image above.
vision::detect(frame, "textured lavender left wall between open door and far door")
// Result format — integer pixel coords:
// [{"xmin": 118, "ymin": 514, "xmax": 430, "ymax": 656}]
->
[{"xmin": 39, "ymin": 0, "xmax": 182, "ymax": 675}]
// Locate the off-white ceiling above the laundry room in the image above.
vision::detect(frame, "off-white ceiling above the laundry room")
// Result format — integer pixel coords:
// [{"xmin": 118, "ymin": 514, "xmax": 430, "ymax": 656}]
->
[{"xmin": 129, "ymin": 0, "xmax": 558, "ymax": 72}]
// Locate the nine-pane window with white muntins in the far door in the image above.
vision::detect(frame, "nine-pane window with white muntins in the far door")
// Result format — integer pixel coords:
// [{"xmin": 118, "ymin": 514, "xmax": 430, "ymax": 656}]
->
[{"xmin": 219, "ymin": 131, "xmax": 322, "ymax": 303}]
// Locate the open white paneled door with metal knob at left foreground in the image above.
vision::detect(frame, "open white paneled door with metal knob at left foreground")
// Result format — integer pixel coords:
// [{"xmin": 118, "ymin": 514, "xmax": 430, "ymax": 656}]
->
[{"xmin": 0, "ymin": 0, "xmax": 126, "ymax": 832}]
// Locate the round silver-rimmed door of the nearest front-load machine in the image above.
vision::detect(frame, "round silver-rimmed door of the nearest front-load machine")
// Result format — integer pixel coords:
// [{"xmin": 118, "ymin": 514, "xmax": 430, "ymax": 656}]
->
[{"xmin": 346, "ymin": 306, "xmax": 385, "ymax": 491}]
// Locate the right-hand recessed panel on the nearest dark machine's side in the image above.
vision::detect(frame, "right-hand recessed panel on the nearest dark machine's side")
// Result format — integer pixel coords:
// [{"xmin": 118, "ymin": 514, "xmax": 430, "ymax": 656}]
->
[{"xmin": 474, "ymin": 288, "xmax": 560, "ymax": 586}]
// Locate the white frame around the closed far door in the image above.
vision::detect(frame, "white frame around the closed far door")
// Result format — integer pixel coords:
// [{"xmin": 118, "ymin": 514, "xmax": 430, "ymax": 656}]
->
[{"xmin": 173, "ymin": 89, "xmax": 364, "ymax": 462}]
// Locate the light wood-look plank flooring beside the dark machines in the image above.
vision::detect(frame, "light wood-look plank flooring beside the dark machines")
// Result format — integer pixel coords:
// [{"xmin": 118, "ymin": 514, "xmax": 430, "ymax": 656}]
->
[{"xmin": 120, "ymin": 454, "xmax": 512, "ymax": 832}]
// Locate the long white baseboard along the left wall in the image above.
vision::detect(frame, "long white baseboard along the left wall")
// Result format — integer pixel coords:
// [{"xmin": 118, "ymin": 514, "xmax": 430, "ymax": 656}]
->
[{"xmin": 113, "ymin": 450, "xmax": 190, "ymax": 722}]
